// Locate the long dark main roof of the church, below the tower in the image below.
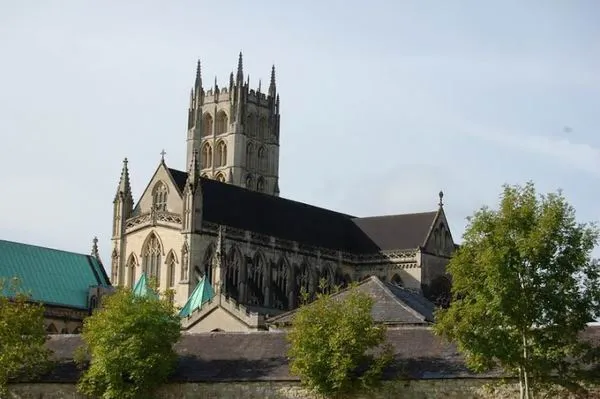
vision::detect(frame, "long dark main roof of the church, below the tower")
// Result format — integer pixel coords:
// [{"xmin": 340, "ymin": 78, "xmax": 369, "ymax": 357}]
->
[{"xmin": 169, "ymin": 168, "xmax": 437, "ymax": 254}]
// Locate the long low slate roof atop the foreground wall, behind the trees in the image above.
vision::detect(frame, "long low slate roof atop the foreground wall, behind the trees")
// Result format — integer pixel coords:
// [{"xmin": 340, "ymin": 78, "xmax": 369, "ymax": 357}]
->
[{"xmin": 35, "ymin": 327, "xmax": 600, "ymax": 382}]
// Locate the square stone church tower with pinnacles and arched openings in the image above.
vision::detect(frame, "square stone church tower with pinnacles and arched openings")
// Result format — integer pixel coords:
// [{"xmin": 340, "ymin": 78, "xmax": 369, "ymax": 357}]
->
[{"xmin": 186, "ymin": 53, "xmax": 279, "ymax": 195}]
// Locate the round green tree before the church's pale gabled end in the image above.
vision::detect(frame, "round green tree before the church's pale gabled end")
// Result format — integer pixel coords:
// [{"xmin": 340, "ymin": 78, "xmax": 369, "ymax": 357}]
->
[{"xmin": 77, "ymin": 289, "xmax": 180, "ymax": 399}]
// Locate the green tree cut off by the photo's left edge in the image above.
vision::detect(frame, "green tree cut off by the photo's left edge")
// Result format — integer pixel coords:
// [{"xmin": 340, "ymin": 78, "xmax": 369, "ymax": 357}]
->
[{"xmin": 0, "ymin": 279, "xmax": 52, "ymax": 397}]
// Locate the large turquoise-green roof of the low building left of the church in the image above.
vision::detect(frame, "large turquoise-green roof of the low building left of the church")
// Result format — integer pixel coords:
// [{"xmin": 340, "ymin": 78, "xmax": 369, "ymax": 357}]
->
[{"xmin": 0, "ymin": 240, "xmax": 110, "ymax": 309}]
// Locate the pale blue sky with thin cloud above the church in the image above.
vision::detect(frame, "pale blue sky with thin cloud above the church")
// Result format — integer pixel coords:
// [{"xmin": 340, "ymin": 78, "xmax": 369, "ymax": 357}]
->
[{"xmin": 0, "ymin": 0, "xmax": 600, "ymax": 263}]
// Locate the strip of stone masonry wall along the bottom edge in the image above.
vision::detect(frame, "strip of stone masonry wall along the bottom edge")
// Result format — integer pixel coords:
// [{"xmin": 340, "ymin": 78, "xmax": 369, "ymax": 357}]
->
[{"xmin": 9, "ymin": 379, "xmax": 600, "ymax": 399}]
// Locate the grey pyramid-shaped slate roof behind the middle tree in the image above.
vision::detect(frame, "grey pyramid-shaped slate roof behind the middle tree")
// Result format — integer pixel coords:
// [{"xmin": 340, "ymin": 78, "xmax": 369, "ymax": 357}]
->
[{"xmin": 267, "ymin": 276, "xmax": 435, "ymax": 325}]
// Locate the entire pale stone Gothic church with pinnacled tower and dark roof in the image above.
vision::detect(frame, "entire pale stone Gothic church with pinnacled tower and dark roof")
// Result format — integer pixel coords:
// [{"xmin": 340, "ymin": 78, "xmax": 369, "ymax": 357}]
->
[{"xmin": 111, "ymin": 54, "xmax": 455, "ymax": 331}]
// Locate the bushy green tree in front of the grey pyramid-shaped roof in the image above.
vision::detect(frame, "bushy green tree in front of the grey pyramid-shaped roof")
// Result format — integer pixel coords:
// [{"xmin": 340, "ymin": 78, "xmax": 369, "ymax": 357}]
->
[{"xmin": 287, "ymin": 288, "xmax": 391, "ymax": 397}]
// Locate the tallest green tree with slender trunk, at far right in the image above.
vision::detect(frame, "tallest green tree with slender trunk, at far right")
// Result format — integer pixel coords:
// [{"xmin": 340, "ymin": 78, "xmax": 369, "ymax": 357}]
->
[{"xmin": 434, "ymin": 182, "xmax": 600, "ymax": 398}]
